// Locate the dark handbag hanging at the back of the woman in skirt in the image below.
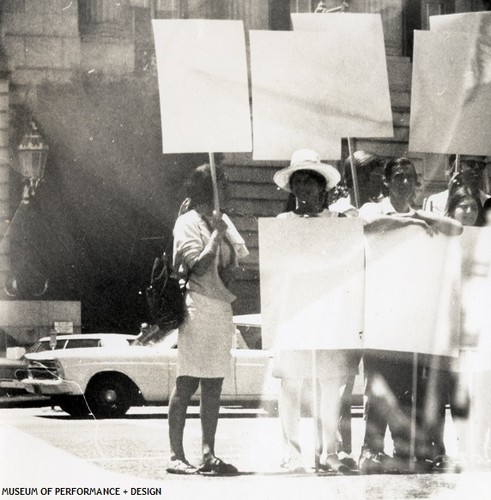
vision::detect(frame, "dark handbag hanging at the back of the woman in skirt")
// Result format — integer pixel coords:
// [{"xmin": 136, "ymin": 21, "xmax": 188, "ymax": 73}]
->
[{"xmin": 146, "ymin": 252, "xmax": 189, "ymax": 331}]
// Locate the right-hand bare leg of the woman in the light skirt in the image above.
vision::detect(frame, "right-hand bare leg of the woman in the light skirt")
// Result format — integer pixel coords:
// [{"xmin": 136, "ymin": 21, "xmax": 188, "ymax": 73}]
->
[{"xmin": 200, "ymin": 378, "xmax": 223, "ymax": 462}]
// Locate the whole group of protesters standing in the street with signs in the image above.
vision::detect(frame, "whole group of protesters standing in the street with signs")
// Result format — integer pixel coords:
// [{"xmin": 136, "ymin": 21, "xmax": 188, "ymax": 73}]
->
[{"xmin": 167, "ymin": 149, "xmax": 489, "ymax": 475}]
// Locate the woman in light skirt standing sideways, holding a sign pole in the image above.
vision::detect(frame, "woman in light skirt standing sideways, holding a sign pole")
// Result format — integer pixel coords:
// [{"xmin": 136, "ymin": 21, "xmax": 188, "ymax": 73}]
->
[{"xmin": 167, "ymin": 164, "xmax": 248, "ymax": 475}]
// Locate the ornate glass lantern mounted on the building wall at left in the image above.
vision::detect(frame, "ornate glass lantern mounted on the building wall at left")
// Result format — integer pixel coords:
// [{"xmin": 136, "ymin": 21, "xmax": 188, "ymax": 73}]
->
[{"xmin": 17, "ymin": 121, "xmax": 49, "ymax": 204}]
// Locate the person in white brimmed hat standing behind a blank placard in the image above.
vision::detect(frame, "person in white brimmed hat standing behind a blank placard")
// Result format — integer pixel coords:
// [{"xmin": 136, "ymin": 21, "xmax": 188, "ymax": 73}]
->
[{"xmin": 273, "ymin": 149, "xmax": 359, "ymax": 473}]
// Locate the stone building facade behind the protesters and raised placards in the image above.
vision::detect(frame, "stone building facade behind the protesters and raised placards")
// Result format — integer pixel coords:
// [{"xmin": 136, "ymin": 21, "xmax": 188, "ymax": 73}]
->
[{"xmin": 0, "ymin": 0, "xmax": 489, "ymax": 329}]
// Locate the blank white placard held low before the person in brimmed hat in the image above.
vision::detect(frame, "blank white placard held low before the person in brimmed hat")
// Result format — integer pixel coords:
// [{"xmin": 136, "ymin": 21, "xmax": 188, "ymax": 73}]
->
[{"xmin": 259, "ymin": 217, "xmax": 364, "ymax": 350}]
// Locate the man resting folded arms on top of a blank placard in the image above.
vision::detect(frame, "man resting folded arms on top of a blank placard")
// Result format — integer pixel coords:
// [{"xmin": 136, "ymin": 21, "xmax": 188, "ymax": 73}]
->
[{"xmin": 359, "ymin": 158, "xmax": 462, "ymax": 474}]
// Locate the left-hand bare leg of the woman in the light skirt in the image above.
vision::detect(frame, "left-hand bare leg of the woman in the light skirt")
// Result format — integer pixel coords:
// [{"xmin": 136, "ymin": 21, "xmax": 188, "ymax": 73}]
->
[{"xmin": 169, "ymin": 376, "xmax": 199, "ymax": 462}]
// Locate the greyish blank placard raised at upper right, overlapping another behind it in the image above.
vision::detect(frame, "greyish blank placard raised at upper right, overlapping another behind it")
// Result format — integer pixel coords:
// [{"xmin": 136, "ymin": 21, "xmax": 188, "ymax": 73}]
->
[{"xmin": 409, "ymin": 31, "xmax": 491, "ymax": 155}]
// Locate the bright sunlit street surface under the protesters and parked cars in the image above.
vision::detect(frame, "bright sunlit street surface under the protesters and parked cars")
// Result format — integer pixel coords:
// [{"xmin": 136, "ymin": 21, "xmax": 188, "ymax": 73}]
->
[{"xmin": 0, "ymin": 406, "xmax": 491, "ymax": 500}]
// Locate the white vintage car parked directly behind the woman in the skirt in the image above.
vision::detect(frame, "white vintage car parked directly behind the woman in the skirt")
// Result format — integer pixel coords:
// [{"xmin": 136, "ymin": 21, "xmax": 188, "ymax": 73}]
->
[{"xmin": 22, "ymin": 322, "xmax": 279, "ymax": 418}]
